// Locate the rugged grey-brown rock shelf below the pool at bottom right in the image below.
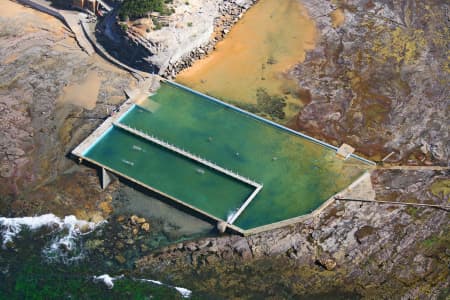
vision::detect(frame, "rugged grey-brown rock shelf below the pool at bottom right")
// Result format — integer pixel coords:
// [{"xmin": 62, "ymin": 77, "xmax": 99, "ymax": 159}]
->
[{"xmin": 136, "ymin": 170, "xmax": 450, "ymax": 299}]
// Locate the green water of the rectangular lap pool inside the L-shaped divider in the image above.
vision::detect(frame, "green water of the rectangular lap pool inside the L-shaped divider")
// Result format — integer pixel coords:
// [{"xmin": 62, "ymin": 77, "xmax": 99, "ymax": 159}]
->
[{"xmin": 85, "ymin": 127, "xmax": 255, "ymax": 220}]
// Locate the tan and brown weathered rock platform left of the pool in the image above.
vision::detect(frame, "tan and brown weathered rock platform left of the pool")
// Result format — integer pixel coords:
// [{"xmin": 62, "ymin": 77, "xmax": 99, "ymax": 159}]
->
[{"xmin": 0, "ymin": 1, "xmax": 134, "ymax": 220}]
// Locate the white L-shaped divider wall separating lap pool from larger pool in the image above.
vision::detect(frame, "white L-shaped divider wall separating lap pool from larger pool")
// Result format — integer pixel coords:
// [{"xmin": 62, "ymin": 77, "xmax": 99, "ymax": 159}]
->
[{"xmin": 113, "ymin": 122, "xmax": 263, "ymax": 224}]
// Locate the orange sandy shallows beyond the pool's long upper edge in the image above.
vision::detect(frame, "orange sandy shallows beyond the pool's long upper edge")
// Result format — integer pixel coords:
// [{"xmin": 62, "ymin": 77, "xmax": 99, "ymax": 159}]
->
[{"xmin": 177, "ymin": 0, "xmax": 317, "ymax": 117}]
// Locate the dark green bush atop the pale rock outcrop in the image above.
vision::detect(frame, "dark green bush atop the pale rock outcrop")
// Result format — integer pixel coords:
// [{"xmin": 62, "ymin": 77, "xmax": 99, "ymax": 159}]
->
[{"xmin": 119, "ymin": 0, "xmax": 172, "ymax": 20}]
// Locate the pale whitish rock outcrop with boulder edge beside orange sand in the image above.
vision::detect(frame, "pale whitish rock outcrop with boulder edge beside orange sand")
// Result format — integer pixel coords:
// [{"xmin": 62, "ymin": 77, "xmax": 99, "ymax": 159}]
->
[{"xmin": 116, "ymin": 0, "xmax": 257, "ymax": 78}]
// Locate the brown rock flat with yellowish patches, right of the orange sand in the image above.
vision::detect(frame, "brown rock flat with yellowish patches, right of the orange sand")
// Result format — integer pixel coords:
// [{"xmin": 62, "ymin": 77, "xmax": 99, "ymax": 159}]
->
[{"xmin": 291, "ymin": 0, "xmax": 450, "ymax": 165}]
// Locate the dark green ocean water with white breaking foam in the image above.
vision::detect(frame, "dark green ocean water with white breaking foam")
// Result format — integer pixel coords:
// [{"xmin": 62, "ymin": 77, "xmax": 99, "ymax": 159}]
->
[{"xmin": 0, "ymin": 214, "xmax": 196, "ymax": 299}]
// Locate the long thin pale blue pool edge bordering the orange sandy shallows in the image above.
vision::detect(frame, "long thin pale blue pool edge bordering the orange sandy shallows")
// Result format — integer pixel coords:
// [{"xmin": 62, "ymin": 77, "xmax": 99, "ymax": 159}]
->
[{"xmin": 164, "ymin": 78, "xmax": 376, "ymax": 165}]
